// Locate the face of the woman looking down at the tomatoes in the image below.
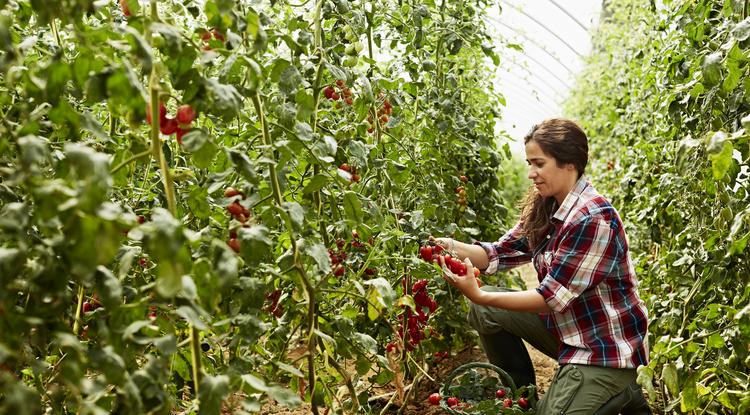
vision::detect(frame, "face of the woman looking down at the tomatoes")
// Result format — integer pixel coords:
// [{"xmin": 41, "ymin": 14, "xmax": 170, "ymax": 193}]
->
[{"xmin": 526, "ymin": 140, "xmax": 578, "ymax": 204}]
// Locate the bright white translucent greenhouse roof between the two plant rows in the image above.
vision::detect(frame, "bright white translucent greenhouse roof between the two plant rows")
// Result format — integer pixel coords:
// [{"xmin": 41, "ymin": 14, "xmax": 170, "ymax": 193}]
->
[{"xmin": 488, "ymin": 0, "xmax": 602, "ymax": 154}]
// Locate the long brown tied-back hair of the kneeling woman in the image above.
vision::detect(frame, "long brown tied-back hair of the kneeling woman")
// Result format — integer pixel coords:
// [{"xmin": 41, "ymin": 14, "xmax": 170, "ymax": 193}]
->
[{"xmin": 521, "ymin": 118, "xmax": 589, "ymax": 249}]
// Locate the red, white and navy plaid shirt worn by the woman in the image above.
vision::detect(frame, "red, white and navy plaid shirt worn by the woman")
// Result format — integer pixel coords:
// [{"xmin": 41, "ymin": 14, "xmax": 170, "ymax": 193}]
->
[{"xmin": 478, "ymin": 177, "xmax": 648, "ymax": 368}]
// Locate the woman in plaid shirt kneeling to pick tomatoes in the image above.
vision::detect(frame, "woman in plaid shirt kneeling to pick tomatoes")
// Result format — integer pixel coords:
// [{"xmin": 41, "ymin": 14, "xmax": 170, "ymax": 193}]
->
[{"xmin": 433, "ymin": 119, "xmax": 649, "ymax": 415}]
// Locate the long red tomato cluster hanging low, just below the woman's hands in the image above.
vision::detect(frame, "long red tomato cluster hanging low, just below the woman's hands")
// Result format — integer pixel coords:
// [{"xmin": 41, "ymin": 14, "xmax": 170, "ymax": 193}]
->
[{"xmin": 386, "ymin": 279, "xmax": 438, "ymax": 352}]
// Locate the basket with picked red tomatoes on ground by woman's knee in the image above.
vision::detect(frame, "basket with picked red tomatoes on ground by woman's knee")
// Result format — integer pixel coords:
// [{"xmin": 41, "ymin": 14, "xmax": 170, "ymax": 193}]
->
[{"xmin": 428, "ymin": 362, "xmax": 536, "ymax": 415}]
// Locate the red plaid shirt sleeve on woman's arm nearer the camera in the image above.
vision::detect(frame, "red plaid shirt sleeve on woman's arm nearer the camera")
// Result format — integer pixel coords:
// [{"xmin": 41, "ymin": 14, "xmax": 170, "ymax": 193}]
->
[{"xmin": 536, "ymin": 215, "xmax": 623, "ymax": 313}]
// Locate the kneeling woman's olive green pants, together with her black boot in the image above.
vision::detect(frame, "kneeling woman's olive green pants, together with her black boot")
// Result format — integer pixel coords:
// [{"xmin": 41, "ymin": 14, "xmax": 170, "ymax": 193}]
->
[{"xmin": 468, "ymin": 286, "xmax": 636, "ymax": 415}]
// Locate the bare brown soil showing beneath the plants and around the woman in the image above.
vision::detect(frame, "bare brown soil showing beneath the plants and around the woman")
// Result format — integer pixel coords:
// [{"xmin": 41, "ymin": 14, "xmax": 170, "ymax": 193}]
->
[{"xmin": 254, "ymin": 265, "xmax": 557, "ymax": 415}]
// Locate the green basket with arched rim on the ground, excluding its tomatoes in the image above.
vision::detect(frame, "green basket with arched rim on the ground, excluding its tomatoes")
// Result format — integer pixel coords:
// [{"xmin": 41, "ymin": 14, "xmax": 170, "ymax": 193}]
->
[{"xmin": 440, "ymin": 362, "xmax": 516, "ymax": 415}]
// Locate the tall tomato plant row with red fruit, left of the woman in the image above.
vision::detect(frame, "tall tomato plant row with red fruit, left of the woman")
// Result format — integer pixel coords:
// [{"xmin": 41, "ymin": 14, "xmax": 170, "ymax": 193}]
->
[{"xmin": 0, "ymin": 0, "xmax": 521, "ymax": 414}]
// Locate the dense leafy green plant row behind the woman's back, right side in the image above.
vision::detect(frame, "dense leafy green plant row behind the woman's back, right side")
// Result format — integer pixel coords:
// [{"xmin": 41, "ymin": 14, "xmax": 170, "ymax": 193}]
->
[{"xmin": 568, "ymin": 0, "xmax": 750, "ymax": 413}]
